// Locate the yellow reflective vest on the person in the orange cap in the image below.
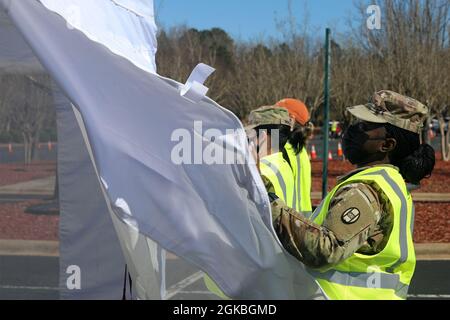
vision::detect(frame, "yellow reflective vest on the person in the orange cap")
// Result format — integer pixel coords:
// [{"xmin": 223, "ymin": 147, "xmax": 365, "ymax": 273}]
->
[{"xmin": 285, "ymin": 143, "xmax": 312, "ymax": 216}]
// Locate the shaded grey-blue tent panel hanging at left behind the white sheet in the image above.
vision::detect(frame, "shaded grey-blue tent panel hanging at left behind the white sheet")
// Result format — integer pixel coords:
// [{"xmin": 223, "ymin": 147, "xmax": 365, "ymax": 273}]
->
[{"xmin": 56, "ymin": 96, "xmax": 132, "ymax": 300}]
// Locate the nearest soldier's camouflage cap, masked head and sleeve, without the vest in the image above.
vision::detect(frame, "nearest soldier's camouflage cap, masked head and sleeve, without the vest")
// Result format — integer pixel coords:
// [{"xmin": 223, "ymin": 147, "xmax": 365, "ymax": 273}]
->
[{"xmin": 265, "ymin": 90, "xmax": 434, "ymax": 278}]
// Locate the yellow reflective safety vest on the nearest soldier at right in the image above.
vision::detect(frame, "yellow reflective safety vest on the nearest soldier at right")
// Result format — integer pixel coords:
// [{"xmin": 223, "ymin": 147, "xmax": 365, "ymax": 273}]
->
[{"xmin": 310, "ymin": 166, "xmax": 415, "ymax": 299}]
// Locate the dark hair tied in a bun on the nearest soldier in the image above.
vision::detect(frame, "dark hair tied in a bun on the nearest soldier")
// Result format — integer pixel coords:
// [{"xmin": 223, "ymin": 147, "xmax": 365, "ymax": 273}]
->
[{"xmin": 384, "ymin": 124, "xmax": 436, "ymax": 184}]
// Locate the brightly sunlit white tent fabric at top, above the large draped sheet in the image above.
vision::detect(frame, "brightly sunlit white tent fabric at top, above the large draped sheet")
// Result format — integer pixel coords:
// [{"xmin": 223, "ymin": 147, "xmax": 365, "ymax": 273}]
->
[{"xmin": 41, "ymin": 0, "xmax": 157, "ymax": 73}]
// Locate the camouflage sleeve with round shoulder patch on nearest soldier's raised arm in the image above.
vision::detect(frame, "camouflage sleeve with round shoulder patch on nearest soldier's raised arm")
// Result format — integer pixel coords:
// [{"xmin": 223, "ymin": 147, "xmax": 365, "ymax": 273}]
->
[{"xmin": 272, "ymin": 183, "xmax": 380, "ymax": 268}]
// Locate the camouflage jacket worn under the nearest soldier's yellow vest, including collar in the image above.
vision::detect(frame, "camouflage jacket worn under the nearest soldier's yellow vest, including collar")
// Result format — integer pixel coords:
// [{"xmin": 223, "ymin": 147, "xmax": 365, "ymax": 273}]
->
[{"xmin": 263, "ymin": 168, "xmax": 393, "ymax": 269}]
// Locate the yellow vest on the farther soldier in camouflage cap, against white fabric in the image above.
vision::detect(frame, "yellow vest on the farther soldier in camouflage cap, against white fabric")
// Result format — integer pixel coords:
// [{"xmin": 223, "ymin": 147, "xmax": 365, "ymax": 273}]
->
[{"xmin": 260, "ymin": 152, "xmax": 294, "ymax": 208}]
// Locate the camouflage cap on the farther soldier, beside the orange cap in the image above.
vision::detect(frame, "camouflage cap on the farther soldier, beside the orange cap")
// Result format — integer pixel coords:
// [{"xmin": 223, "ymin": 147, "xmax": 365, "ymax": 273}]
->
[{"xmin": 245, "ymin": 106, "xmax": 295, "ymax": 130}]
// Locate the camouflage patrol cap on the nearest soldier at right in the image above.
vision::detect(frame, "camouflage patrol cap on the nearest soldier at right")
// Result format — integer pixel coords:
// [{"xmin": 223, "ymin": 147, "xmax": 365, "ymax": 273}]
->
[{"xmin": 347, "ymin": 90, "xmax": 428, "ymax": 133}]
